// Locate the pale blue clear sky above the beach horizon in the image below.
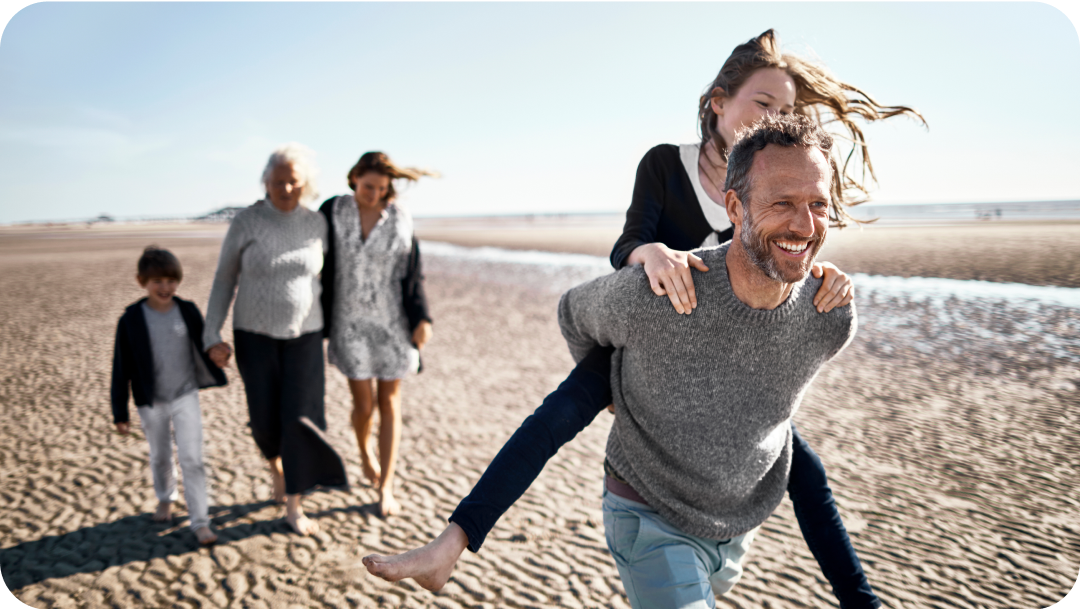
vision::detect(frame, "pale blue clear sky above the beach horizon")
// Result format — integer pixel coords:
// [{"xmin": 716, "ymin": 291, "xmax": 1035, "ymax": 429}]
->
[{"xmin": 0, "ymin": 2, "xmax": 1080, "ymax": 222}]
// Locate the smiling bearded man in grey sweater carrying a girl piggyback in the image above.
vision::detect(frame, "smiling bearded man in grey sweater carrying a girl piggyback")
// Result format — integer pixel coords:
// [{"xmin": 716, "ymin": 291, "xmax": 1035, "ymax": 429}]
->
[{"xmin": 558, "ymin": 116, "xmax": 855, "ymax": 608}]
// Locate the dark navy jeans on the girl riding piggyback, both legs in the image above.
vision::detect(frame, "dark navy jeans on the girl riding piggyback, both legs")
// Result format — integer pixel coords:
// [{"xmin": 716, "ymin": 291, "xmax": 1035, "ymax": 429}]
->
[{"xmin": 449, "ymin": 347, "xmax": 881, "ymax": 609}]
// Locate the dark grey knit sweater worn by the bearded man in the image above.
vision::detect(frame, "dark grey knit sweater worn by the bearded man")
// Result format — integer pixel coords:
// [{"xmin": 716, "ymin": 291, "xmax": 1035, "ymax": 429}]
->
[{"xmin": 558, "ymin": 244, "xmax": 856, "ymax": 539}]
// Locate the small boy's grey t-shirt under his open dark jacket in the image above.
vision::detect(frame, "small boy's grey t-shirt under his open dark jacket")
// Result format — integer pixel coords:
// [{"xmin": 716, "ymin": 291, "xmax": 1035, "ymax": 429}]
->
[{"xmin": 143, "ymin": 302, "xmax": 199, "ymax": 402}]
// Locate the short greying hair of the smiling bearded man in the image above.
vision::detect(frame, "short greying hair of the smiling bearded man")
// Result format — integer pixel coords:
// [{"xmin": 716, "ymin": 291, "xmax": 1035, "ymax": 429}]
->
[{"xmin": 724, "ymin": 114, "xmax": 840, "ymax": 219}]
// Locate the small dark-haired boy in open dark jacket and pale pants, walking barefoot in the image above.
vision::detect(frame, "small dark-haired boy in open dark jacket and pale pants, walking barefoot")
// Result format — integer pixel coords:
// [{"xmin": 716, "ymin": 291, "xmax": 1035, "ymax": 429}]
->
[{"xmin": 111, "ymin": 245, "xmax": 228, "ymax": 545}]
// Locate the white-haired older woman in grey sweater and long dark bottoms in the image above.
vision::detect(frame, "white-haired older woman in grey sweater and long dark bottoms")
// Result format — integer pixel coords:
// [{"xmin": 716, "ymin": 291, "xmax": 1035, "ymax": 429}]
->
[{"xmin": 203, "ymin": 144, "xmax": 346, "ymax": 534}]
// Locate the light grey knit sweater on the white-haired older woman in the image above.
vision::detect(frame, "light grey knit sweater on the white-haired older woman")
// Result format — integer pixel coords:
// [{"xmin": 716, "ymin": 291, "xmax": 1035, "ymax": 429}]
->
[{"xmin": 203, "ymin": 201, "xmax": 326, "ymax": 349}]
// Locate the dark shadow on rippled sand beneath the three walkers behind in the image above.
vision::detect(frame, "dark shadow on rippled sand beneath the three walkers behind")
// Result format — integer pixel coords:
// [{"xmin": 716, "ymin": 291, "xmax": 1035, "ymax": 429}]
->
[{"xmin": 0, "ymin": 501, "xmax": 378, "ymax": 591}]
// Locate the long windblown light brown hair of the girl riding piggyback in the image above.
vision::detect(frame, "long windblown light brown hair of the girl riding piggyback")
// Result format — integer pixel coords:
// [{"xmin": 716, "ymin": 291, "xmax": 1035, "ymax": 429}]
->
[{"xmin": 698, "ymin": 29, "xmax": 927, "ymax": 227}]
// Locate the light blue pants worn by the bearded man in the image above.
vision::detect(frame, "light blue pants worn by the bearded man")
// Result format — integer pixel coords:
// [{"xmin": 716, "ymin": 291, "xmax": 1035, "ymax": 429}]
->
[{"xmin": 604, "ymin": 489, "xmax": 757, "ymax": 609}]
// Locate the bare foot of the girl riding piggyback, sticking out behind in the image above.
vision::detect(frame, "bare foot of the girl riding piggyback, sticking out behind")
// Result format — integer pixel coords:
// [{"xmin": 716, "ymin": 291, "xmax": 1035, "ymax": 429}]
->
[{"xmin": 364, "ymin": 523, "xmax": 469, "ymax": 592}]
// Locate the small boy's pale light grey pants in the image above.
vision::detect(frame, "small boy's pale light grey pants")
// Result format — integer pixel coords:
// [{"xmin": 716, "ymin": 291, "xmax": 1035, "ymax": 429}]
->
[{"xmin": 138, "ymin": 391, "xmax": 210, "ymax": 530}]
